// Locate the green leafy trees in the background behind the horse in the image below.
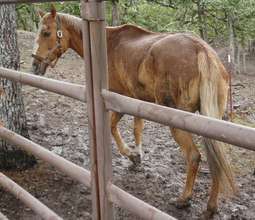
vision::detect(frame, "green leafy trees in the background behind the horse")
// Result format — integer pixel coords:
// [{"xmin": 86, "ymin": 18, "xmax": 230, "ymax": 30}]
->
[{"xmin": 17, "ymin": 0, "xmax": 255, "ymax": 72}]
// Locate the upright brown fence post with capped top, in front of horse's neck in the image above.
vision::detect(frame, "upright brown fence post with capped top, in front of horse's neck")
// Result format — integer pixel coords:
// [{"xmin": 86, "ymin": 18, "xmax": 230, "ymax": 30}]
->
[{"xmin": 81, "ymin": 0, "xmax": 113, "ymax": 220}]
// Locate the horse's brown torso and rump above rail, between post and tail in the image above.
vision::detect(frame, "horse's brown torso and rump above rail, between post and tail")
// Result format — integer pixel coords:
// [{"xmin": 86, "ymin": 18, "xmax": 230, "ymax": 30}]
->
[{"xmin": 108, "ymin": 25, "xmax": 227, "ymax": 111}]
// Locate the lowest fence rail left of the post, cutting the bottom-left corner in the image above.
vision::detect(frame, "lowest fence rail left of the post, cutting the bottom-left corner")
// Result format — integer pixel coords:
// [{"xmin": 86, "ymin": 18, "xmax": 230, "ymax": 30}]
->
[{"xmin": 0, "ymin": 173, "xmax": 62, "ymax": 220}]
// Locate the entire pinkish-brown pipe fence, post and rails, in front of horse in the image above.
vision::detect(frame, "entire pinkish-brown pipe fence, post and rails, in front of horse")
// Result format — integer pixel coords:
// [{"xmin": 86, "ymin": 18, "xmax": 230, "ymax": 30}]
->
[{"xmin": 0, "ymin": 0, "xmax": 255, "ymax": 220}]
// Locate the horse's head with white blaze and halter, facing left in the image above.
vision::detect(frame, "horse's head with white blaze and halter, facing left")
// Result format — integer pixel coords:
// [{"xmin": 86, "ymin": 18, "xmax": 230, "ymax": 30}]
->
[{"xmin": 32, "ymin": 6, "xmax": 69, "ymax": 75}]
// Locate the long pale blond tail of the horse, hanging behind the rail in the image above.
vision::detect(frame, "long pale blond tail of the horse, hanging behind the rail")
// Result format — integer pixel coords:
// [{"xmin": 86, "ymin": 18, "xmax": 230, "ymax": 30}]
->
[{"xmin": 198, "ymin": 50, "xmax": 236, "ymax": 196}]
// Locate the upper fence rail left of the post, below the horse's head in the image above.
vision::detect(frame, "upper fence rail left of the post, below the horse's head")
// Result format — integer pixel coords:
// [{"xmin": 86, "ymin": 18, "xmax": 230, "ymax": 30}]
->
[{"xmin": 0, "ymin": 67, "xmax": 86, "ymax": 102}]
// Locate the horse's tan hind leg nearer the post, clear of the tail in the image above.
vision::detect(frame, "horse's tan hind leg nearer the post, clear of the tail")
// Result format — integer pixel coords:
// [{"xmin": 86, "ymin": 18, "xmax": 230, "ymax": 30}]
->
[{"xmin": 170, "ymin": 128, "xmax": 201, "ymax": 208}]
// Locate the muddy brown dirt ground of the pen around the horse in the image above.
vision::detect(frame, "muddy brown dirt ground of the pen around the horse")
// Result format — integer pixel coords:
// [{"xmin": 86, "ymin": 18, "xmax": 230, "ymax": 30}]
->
[{"xmin": 0, "ymin": 32, "xmax": 255, "ymax": 220}]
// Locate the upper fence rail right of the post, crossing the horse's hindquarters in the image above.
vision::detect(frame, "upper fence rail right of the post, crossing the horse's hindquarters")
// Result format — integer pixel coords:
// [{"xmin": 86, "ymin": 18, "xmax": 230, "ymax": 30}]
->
[{"xmin": 102, "ymin": 90, "xmax": 255, "ymax": 151}]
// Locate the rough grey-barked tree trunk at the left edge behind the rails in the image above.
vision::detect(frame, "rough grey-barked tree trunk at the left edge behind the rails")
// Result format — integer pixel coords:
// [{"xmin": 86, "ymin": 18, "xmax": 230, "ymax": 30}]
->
[{"xmin": 0, "ymin": 4, "xmax": 36, "ymax": 169}]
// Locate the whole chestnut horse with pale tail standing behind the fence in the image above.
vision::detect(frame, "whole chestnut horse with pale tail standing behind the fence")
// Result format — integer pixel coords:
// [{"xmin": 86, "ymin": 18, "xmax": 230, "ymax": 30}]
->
[{"xmin": 32, "ymin": 7, "xmax": 236, "ymax": 219}]
